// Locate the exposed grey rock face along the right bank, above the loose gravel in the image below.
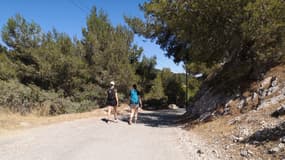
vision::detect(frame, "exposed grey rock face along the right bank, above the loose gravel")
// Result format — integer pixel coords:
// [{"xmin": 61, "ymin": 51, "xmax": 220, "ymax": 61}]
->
[{"xmin": 186, "ymin": 71, "xmax": 285, "ymax": 121}]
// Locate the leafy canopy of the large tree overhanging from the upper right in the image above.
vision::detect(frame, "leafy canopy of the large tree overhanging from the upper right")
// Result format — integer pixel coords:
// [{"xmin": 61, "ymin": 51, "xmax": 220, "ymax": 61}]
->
[{"xmin": 125, "ymin": 0, "xmax": 285, "ymax": 74}]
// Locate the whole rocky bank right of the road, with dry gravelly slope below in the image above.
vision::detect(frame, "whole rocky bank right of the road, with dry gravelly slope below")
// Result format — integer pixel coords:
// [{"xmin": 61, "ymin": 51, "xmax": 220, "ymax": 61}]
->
[{"xmin": 183, "ymin": 65, "xmax": 285, "ymax": 159}]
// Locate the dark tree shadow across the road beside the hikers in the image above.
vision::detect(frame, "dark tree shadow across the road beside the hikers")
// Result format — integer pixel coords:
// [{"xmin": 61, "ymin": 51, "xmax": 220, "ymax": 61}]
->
[{"xmin": 117, "ymin": 109, "xmax": 185, "ymax": 128}]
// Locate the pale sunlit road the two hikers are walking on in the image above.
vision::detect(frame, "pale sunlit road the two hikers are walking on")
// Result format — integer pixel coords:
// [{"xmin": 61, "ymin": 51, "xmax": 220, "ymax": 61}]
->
[{"xmin": 0, "ymin": 110, "xmax": 215, "ymax": 160}]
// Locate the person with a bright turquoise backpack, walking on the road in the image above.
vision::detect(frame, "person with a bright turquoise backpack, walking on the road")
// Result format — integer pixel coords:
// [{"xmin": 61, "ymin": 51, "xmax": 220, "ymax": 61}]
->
[{"xmin": 129, "ymin": 84, "xmax": 142, "ymax": 125}]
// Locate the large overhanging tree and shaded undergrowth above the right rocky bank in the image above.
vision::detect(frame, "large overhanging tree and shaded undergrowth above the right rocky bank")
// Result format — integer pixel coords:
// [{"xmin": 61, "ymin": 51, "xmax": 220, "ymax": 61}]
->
[{"xmin": 125, "ymin": 0, "xmax": 285, "ymax": 114}]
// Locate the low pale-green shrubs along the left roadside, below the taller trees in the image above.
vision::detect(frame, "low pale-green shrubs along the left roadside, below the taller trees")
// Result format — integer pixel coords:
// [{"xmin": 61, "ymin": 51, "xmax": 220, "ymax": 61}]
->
[{"xmin": 0, "ymin": 80, "xmax": 98, "ymax": 116}]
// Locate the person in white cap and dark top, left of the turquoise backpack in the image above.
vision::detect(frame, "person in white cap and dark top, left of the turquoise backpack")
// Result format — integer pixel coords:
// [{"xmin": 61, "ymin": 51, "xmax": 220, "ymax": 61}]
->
[{"xmin": 106, "ymin": 81, "xmax": 119, "ymax": 123}]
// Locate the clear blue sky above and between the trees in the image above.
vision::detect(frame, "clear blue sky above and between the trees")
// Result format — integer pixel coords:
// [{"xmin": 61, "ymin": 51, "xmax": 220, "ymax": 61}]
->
[{"xmin": 0, "ymin": 0, "xmax": 184, "ymax": 73}]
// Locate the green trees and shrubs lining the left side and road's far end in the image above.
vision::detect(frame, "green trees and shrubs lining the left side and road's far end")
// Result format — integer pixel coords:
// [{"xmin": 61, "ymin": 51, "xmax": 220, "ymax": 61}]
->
[{"xmin": 0, "ymin": 7, "xmax": 192, "ymax": 115}]
